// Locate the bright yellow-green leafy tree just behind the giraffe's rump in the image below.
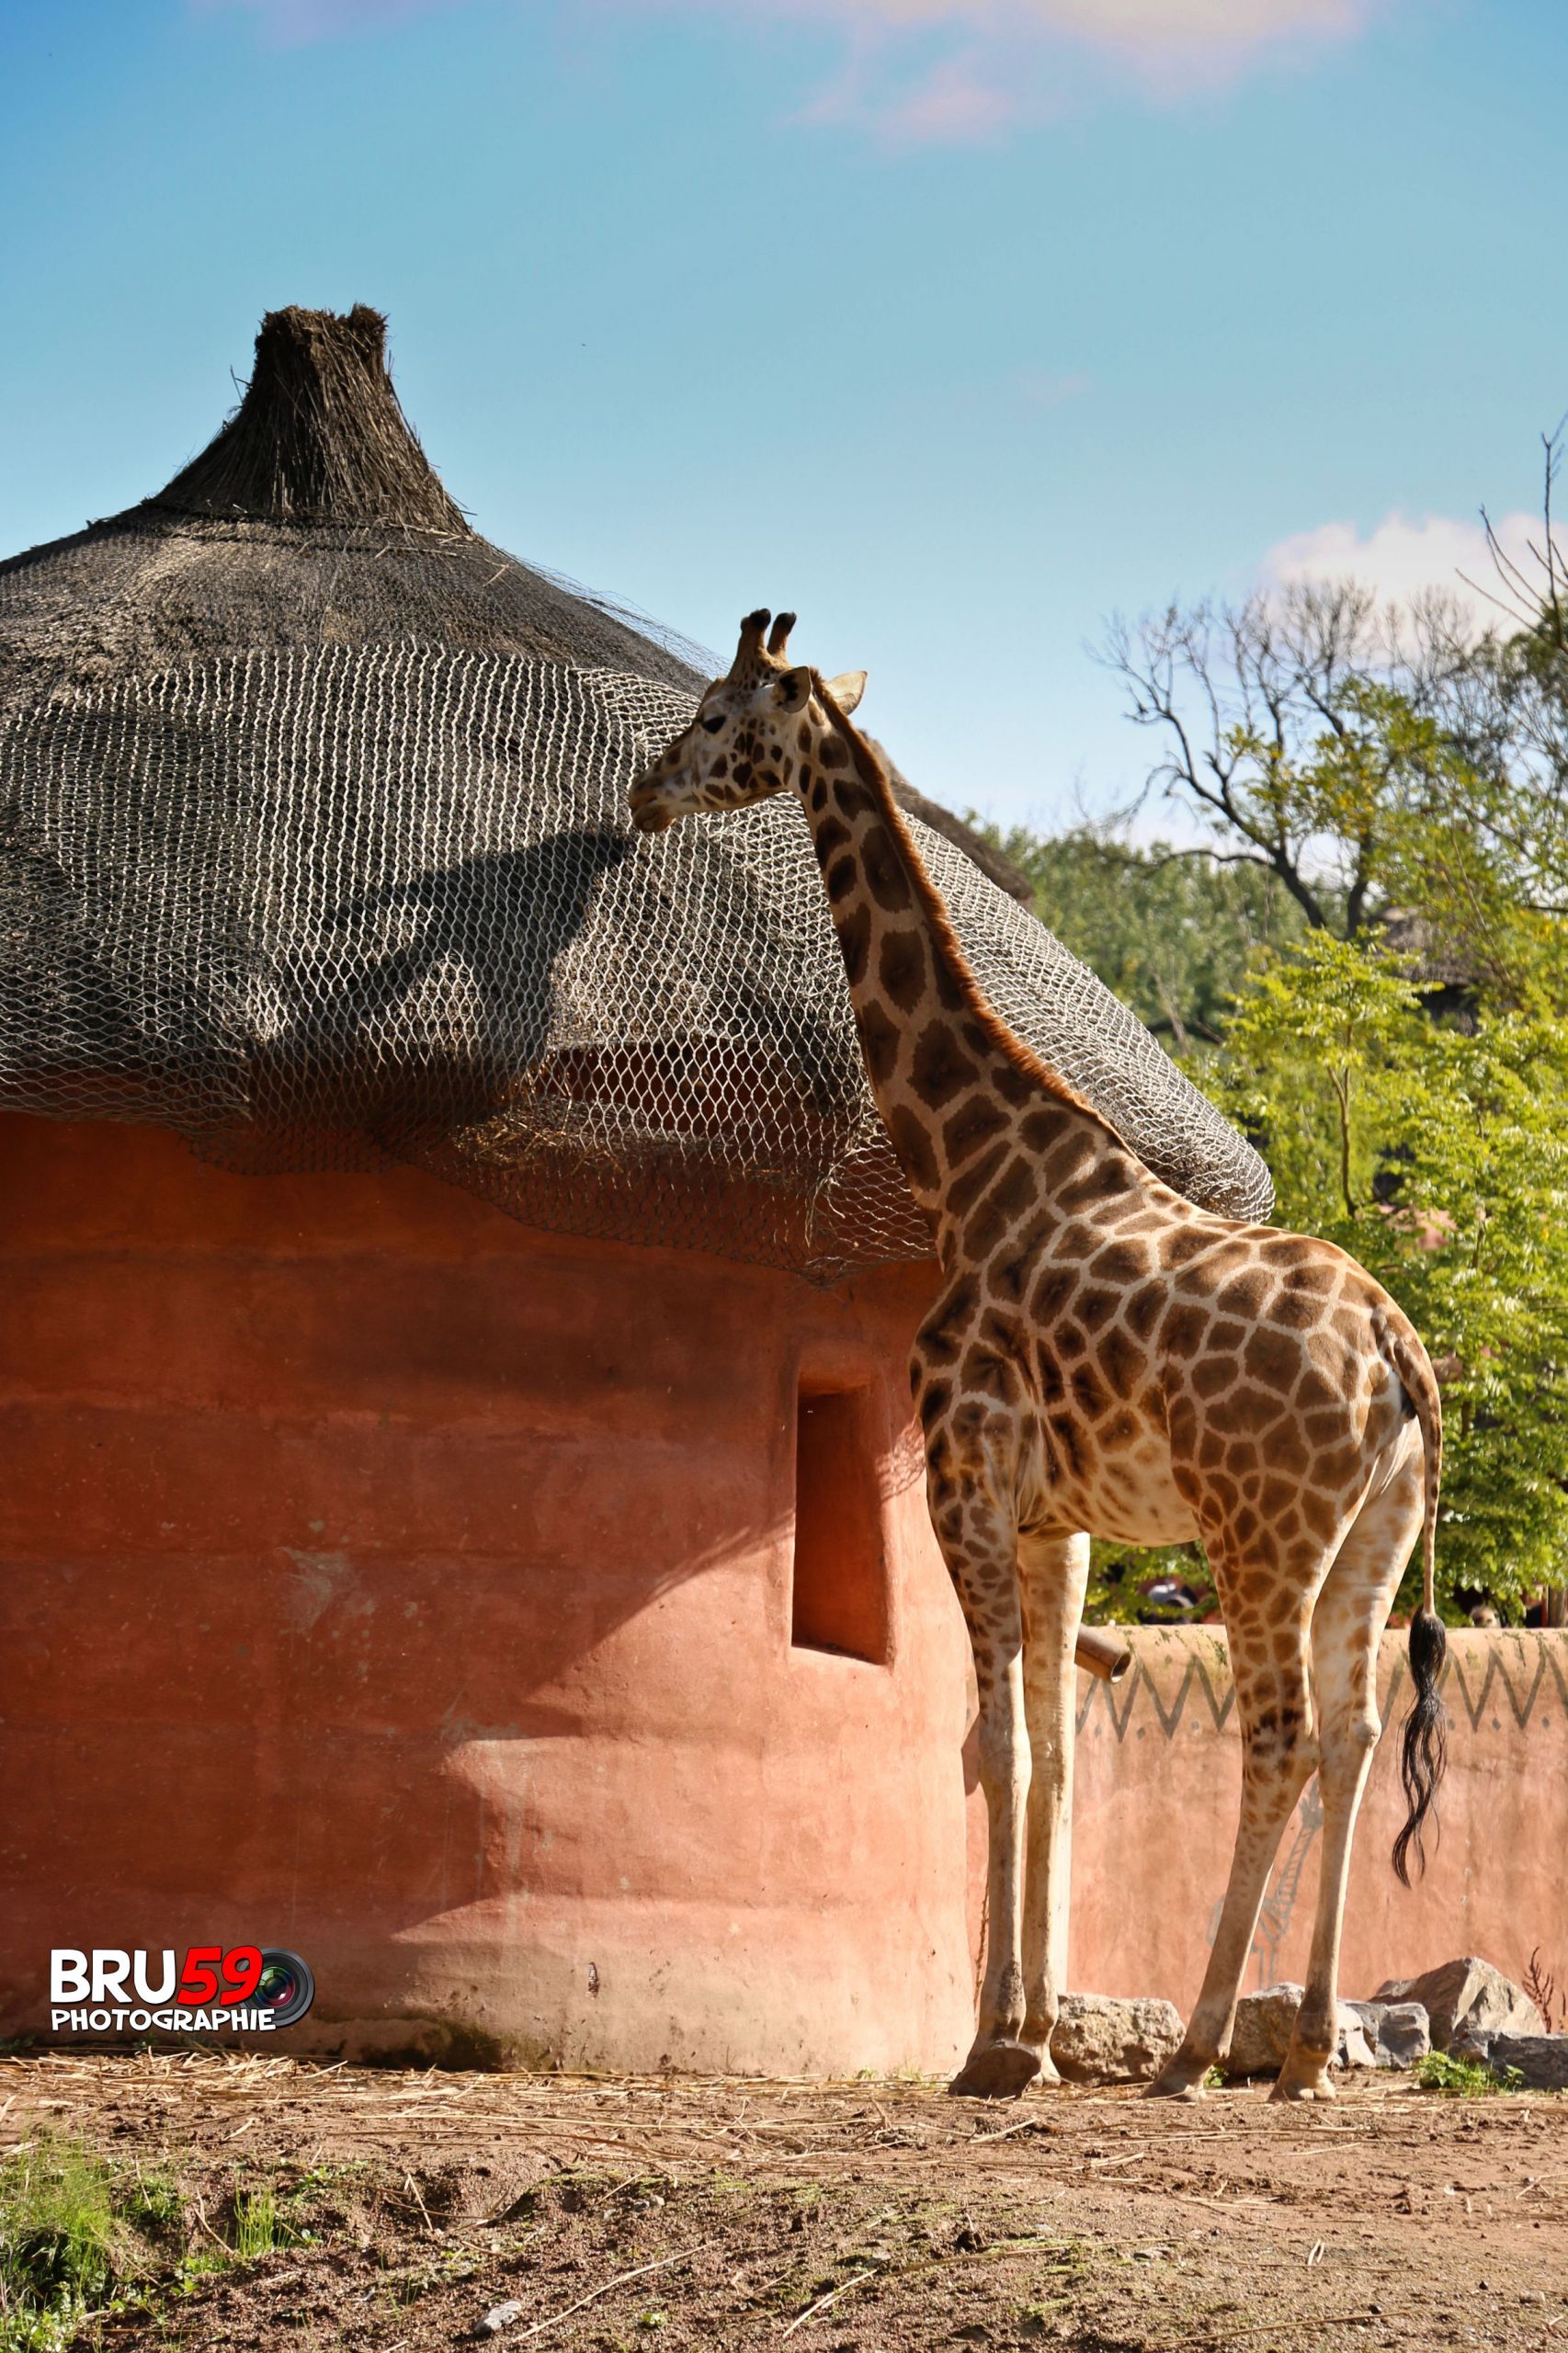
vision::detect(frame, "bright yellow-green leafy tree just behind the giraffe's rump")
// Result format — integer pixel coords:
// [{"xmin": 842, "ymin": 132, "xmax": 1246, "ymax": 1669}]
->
[{"xmin": 1210, "ymin": 932, "xmax": 1568, "ymax": 1617}]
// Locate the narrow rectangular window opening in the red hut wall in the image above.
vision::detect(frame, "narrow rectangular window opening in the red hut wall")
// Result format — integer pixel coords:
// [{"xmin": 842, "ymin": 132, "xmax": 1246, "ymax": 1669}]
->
[{"xmin": 789, "ymin": 1383, "xmax": 888, "ymax": 1665}]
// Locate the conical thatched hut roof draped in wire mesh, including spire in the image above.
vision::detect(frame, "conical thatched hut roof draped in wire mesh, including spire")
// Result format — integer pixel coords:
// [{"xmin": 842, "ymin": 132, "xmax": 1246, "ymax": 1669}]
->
[{"xmin": 0, "ymin": 311, "xmax": 1269, "ymax": 1278}]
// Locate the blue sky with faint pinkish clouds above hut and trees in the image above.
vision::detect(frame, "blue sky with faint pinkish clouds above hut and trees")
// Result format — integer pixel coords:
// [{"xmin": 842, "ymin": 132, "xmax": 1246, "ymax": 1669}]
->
[{"xmin": 0, "ymin": 0, "xmax": 1568, "ymax": 824}]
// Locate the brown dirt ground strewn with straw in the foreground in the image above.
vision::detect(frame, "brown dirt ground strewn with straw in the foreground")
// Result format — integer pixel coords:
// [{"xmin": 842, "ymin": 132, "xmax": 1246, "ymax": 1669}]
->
[{"xmin": 0, "ymin": 2052, "xmax": 1568, "ymax": 2353}]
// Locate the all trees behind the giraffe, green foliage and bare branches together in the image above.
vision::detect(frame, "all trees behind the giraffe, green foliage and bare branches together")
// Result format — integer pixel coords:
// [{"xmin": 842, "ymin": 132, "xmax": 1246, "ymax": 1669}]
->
[{"xmin": 1003, "ymin": 445, "xmax": 1568, "ymax": 1619}]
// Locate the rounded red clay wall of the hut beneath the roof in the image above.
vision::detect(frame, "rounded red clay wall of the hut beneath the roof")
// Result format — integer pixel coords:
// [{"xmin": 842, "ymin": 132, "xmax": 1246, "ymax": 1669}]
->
[{"xmin": 0, "ymin": 1120, "xmax": 970, "ymax": 2071}]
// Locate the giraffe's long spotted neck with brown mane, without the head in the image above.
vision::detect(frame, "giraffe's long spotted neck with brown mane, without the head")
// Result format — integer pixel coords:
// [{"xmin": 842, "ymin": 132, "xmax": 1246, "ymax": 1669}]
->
[{"xmin": 796, "ymin": 687, "xmax": 1142, "ymax": 1264}]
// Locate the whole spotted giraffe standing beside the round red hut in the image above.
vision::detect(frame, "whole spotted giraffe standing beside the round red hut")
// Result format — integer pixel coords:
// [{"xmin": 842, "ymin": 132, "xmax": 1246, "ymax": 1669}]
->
[{"xmin": 631, "ymin": 612, "xmax": 1443, "ymax": 2099}]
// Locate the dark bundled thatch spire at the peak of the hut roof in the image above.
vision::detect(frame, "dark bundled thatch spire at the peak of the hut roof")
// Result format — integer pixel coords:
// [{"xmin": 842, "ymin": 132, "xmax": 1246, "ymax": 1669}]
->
[{"xmin": 148, "ymin": 303, "xmax": 473, "ymax": 539}]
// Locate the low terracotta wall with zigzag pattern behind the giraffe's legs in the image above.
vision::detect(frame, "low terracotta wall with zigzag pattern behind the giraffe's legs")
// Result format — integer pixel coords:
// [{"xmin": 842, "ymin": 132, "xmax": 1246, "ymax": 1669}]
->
[{"xmin": 1069, "ymin": 1626, "xmax": 1568, "ymax": 2017}]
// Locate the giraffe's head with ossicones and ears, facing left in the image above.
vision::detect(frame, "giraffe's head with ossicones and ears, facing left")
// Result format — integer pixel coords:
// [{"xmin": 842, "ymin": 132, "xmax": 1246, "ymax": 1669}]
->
[{"xmin": 631, "ymin": 612, "xmax": 867, "ymax": 833}]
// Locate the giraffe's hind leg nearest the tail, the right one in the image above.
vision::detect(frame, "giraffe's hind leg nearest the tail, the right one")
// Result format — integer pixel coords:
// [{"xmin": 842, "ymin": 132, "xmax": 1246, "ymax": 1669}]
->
[{"xmin": 1274, "ymin": 1424, "xmax": 1422, "ymax": 2099}]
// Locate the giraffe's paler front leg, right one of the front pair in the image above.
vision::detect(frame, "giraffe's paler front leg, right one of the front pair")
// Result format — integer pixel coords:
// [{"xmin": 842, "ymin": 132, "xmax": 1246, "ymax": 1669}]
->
[{"xmin": 1017, "ymin": 1534, "xmax": 1090, "ymax": 2083}]
